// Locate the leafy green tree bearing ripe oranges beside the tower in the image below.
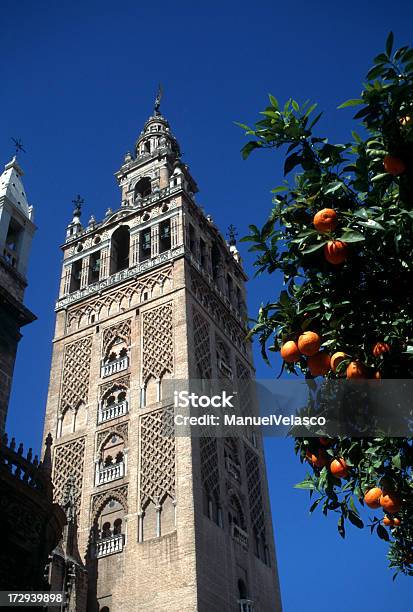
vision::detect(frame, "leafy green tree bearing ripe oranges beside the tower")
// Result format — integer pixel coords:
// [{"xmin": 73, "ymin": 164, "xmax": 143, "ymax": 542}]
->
[{"xmin": 239, "ymin": 33, "xmax": 413, "ymax": 575}]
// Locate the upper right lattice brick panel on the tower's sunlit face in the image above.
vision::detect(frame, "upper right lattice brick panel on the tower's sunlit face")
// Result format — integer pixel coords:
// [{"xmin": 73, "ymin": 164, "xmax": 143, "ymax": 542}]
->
[{"xmin": 142, "ymin": 302, "xmax": 173, "ymax": 383}]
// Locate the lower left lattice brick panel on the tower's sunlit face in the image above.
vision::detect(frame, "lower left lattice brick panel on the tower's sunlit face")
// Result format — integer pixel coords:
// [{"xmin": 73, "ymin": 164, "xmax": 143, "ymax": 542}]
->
[{"xmin": 53, "ymin": 438, "xmax": 85, "ymax": 514}]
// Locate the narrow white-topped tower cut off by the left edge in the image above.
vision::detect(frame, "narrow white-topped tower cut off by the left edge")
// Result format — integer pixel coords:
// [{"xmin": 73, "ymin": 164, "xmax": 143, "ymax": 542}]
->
[{"xmin": 0, "ymin": 157, "xmax": 36, "ymax": 435}]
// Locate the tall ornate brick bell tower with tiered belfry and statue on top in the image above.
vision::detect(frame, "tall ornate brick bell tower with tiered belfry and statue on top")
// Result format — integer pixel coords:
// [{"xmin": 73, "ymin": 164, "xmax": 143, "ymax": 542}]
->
[{"xmin": 41, "ymin": 98, "xmax": 281, "ymax": 612}]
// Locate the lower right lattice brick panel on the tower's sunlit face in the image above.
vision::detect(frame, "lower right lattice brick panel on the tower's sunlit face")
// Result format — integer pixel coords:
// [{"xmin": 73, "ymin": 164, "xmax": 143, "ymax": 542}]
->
[{"xmin": 139, "ymin": 406, "xmax": 175, "ymax": 508}]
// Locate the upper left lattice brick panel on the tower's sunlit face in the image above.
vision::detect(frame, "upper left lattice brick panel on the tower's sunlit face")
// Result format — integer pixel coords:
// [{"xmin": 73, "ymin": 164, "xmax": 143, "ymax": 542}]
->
[{"xmin": 60, "ymin": 336, "xmax": 92, "ymax": 412}]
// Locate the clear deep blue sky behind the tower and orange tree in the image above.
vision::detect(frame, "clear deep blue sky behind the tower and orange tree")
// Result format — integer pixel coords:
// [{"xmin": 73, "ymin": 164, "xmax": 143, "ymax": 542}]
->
[{"xmin": 0, "ymin": 0, "xmax": 413, "ymax": 612}]
